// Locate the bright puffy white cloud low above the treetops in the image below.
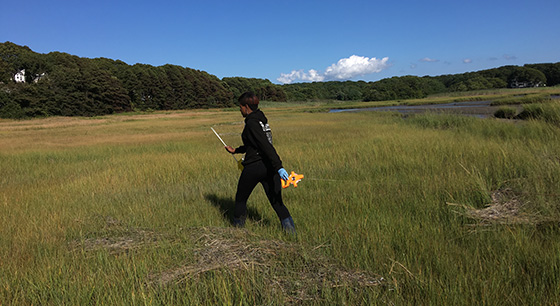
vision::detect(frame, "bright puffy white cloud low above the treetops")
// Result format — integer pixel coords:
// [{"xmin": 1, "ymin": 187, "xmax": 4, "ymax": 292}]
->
[{"xmin": 276, "ymin": 55, "xmax": 390, "ymax": 84}]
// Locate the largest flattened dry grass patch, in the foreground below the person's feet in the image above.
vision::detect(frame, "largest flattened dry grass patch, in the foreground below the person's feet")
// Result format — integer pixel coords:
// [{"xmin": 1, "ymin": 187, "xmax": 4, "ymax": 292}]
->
[{"xmin": 148, "ymin": 227, "xmax": 385, "ymax": 302}]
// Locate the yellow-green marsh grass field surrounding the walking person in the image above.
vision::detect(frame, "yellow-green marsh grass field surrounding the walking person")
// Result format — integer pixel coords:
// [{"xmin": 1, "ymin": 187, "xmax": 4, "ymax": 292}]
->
[{"xmin": 0, "ymin": 106, "xmax": 560, "ymax": 305}]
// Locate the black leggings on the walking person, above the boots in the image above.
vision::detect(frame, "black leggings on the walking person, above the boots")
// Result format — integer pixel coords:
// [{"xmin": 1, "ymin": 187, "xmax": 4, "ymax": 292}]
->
[{"xmin": 233, "ymin": 161, "xmax": 290, "ymax": 220}]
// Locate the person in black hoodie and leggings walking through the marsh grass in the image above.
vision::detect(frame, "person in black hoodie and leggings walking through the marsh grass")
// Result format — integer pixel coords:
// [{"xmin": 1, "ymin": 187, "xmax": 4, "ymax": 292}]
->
[{"xmin": 225, "ymin": 92, "xmax": 295, "ymax": 234}]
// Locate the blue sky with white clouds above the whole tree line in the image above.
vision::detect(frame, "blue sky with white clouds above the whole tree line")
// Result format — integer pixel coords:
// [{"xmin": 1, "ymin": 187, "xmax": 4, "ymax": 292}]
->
[{"xmin": 0, "ymin": 0, "xmax": 560, "ymax": 84}]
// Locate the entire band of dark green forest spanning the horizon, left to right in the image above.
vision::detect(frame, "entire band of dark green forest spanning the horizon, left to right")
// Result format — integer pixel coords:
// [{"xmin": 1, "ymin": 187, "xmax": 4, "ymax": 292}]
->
[{"xmin": 0, "ymin": 42, "xmax": 560, "ymax": 118}]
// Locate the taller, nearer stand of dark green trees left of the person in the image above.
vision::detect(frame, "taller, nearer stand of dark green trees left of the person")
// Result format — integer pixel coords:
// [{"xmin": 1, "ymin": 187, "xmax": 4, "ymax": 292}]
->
[{"xmin": 0, "ymin": 42, "xmax": 233, "ymax": 118}]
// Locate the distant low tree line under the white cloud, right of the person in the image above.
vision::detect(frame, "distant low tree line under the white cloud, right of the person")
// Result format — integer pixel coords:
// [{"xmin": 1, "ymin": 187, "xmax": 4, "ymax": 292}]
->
[{"xmin": 282, "ymin": 63, "xmax": 560, "ymax": 101}]
